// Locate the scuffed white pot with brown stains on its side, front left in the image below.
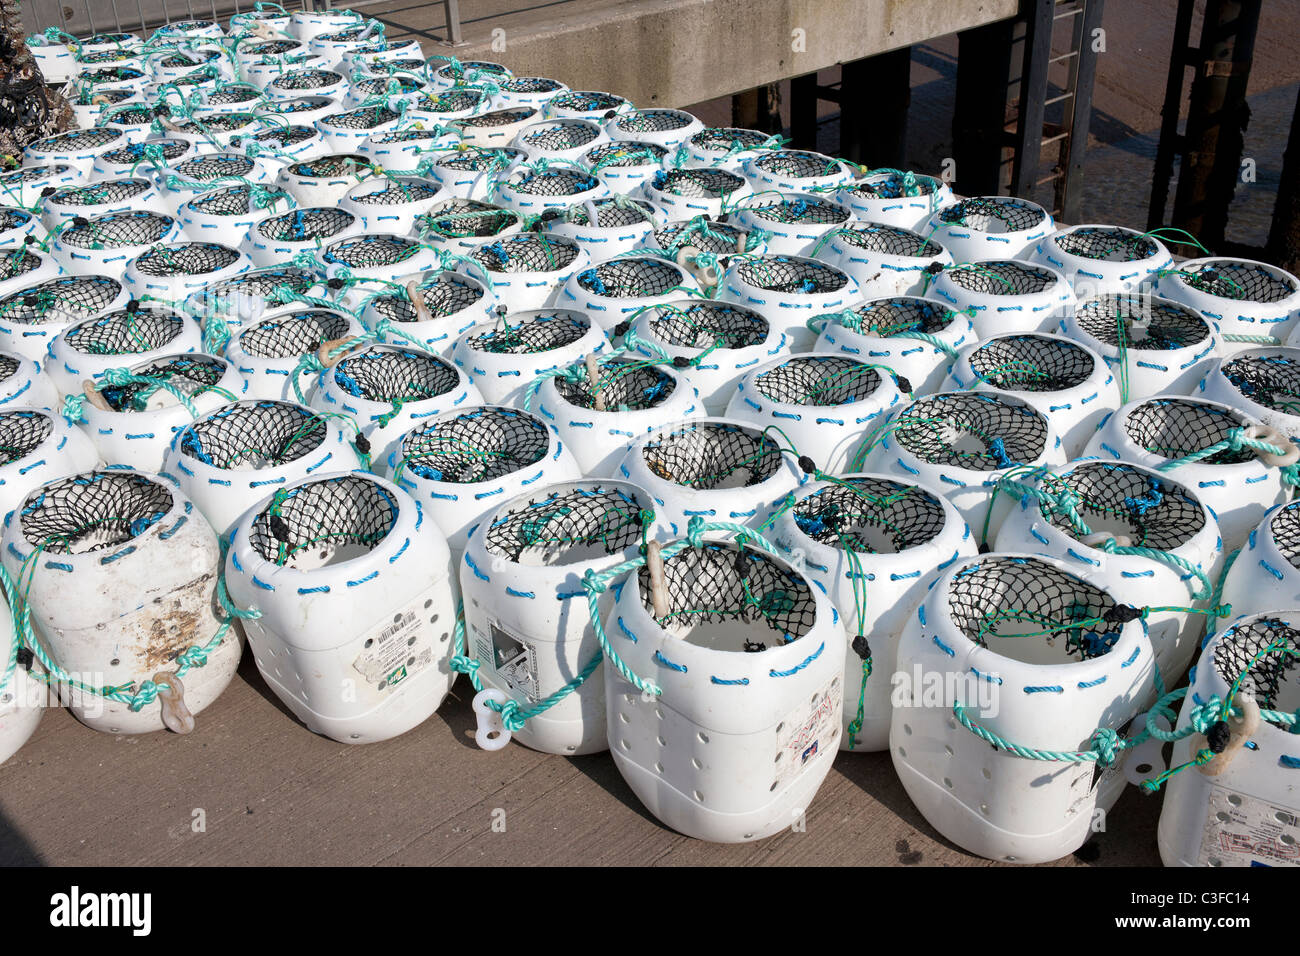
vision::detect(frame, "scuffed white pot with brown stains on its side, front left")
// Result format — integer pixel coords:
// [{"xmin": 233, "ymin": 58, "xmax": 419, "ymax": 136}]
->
[{"xmin": 4, "ymin": 471, "xmax": 243, "ymax": 734}]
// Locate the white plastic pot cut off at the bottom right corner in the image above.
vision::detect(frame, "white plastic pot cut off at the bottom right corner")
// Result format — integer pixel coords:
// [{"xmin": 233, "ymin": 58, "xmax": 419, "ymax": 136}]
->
[{"xmin": 1157, "ymin": 609, "xmax": 1300, "ymax": 866}]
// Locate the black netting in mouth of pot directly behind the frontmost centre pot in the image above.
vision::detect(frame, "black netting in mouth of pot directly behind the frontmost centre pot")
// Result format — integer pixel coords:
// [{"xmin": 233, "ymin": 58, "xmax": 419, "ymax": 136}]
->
[{"xmin": 641, "ymin": 421, "xmax": 781, "ymax": 490}]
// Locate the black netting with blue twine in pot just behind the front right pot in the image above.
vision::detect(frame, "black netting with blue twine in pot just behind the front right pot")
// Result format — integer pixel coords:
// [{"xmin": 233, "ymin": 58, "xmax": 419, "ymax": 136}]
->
[{"xmin": 1041, "ymin": 462, "xmax": 1205, "ymax": 551}]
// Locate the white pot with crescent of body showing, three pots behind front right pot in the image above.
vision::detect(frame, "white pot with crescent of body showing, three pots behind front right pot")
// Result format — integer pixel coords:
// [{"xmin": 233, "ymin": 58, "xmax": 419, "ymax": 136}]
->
[{"xmin": 943, "ymin": 333, "xmax": 1119, "ymax": 458}]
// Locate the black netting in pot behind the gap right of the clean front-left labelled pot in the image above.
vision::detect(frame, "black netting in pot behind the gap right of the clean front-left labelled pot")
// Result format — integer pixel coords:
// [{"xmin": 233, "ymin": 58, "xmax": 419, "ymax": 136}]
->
[{"xmin": 398, "ymin": 407, "xmax": 550, "ymax": 484}]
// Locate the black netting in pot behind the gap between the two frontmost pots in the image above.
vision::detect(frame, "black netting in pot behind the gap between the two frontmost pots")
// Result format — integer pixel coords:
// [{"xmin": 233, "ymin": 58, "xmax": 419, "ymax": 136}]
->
[{"xmin": 790, "ymin": 477, "xmax": 946, "ymax": 554}]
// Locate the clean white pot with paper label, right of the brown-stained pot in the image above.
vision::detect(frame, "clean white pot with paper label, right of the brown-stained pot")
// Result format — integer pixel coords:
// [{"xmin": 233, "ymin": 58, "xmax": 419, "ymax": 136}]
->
[{"xmin": 226, "ymin": 472, "xmax": 456, "ymax": 744}]
